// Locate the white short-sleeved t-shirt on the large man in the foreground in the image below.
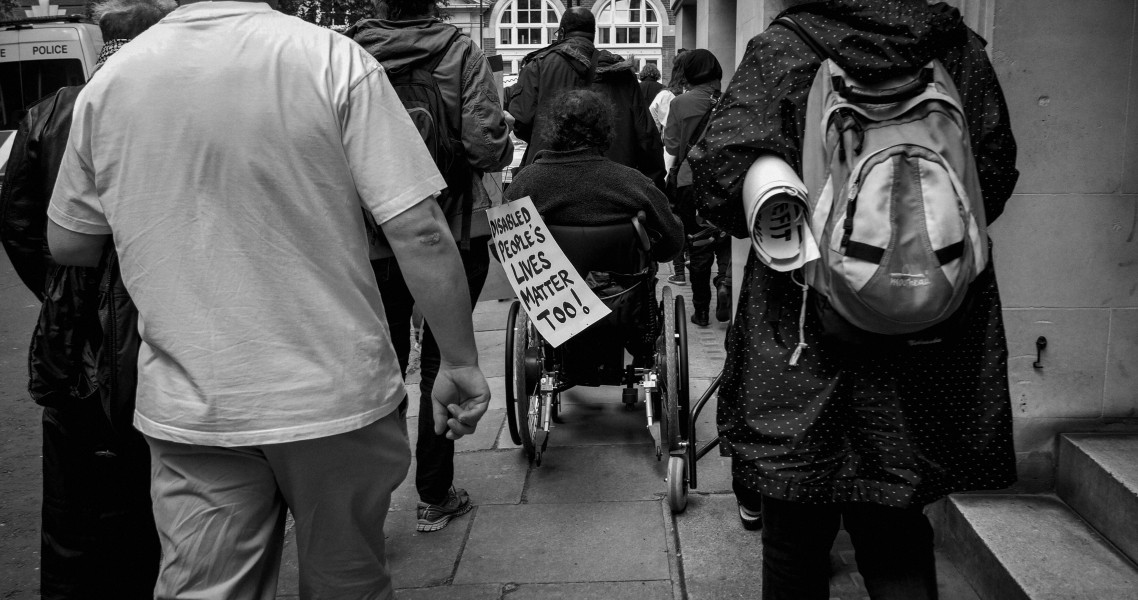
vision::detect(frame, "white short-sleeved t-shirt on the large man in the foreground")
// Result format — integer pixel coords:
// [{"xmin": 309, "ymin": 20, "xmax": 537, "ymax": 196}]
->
[{"xmin": 49, "ymin": 2, "xmax": 445, "ymax": 446}]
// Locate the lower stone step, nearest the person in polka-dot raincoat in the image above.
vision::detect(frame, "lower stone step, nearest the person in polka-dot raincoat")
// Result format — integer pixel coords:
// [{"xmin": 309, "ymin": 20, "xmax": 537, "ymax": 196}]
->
[{"xmin": 940, "ymin": 494, "xmax": 1138, "ymax": 600}]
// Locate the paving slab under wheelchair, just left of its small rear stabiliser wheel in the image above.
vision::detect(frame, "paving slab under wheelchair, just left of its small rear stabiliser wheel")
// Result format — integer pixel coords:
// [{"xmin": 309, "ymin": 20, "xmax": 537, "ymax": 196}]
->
[{"xmin": 526, "ymin": 444, "xmax": 667, "ymax": 504}]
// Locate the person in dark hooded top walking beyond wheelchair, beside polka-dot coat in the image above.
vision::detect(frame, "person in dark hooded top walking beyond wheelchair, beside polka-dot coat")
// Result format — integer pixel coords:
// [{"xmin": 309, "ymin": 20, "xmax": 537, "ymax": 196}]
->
[{"xmin": 663, "ymin": 48, "xmax": 731, "ymax": 327}]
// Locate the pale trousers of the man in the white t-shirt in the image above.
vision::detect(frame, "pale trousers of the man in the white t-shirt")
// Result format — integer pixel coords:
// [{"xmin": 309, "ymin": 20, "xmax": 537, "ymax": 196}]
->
[{"xmin": 147, "ymin": 411, "xmax": 411, "ymax": 600}]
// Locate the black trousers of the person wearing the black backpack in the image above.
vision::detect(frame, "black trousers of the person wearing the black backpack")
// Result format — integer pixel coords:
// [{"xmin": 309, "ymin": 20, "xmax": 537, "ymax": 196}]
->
[{"xmin": 371, "ymin": 237, "xmax": 490, "ymax": 504}]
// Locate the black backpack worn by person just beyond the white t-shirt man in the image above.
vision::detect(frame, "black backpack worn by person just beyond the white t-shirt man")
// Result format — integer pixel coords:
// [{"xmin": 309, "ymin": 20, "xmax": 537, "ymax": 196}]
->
[{"xmin": 376, "ymin": 28, "xmax": 473, "ymax": 249}]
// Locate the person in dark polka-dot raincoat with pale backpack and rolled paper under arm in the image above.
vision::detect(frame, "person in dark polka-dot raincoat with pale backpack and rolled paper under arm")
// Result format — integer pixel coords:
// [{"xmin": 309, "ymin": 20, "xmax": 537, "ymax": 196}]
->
[{"xmin": 690, "ymin": 0, "xmax": 1019, "ymax": 600}]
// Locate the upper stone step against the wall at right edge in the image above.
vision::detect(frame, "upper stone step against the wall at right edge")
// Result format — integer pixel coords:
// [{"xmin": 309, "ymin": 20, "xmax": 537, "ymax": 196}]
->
[{"xmin": 1055, "ymin": 434, "xmax": 1138, "ymax": 566}]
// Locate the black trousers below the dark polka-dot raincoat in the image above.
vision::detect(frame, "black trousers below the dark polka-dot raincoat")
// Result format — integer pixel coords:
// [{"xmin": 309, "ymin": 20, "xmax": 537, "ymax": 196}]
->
[{"xmin": 762, "ymin": 498, "xmax": 937, "ymax": 600}]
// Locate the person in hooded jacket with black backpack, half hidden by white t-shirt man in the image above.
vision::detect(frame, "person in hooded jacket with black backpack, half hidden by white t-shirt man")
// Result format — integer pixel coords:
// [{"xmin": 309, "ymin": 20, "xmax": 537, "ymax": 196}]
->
[{"xmin": 345, "ymin": 0, "xmax": 513, "ymax": 532}]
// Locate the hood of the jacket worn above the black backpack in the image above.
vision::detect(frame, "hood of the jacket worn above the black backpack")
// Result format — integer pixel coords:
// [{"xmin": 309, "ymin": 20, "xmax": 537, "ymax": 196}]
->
[{"xmin": 344, "ymin": 18, "xmax": 455, "ymax": 71}]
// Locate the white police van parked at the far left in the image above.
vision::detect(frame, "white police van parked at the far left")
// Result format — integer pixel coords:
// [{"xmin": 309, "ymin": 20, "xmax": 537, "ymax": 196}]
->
[{"xmin": 0, "ymin": 15, "xmax": 102, "ymax": 181}]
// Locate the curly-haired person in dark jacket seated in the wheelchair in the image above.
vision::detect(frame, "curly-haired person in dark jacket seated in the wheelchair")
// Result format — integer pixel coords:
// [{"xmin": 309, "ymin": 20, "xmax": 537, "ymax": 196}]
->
[{"xmin": 505, "ymin": 90, "xmax": 684, "ymax": 364}]
